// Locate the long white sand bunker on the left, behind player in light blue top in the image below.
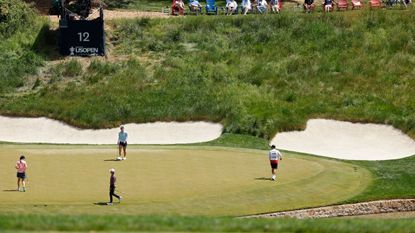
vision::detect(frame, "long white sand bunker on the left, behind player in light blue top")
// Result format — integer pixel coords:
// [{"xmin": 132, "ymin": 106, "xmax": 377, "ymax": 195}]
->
[{"xmin": 0, "ymin": 116, "xmax": 223, "ymax": 144}]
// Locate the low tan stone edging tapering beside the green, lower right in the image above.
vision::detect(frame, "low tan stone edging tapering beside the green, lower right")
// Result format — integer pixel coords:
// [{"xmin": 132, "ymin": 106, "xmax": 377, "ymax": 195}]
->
[{"xmin": 244, "ymin": 199, "xmax": 415, "ymax": 219}]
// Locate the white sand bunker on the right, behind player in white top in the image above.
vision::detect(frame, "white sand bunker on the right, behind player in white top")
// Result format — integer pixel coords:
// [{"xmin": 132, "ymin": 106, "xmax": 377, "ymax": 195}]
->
[{"xmin": 271, "ymin": 119, "xmax": 415, "ymax": 160}]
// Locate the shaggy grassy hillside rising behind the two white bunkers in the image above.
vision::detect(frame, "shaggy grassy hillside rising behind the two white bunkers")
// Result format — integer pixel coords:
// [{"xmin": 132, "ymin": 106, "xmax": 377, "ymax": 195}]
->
[{"xmin": 0, "ymin": 10, "xmax": 415, "ymax": 138}]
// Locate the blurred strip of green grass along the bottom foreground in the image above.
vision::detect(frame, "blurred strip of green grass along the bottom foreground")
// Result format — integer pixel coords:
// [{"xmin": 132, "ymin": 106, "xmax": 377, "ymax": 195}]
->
[{"xmin": 0, "ymin": 214, "xmax": 415, "ymax": 233}]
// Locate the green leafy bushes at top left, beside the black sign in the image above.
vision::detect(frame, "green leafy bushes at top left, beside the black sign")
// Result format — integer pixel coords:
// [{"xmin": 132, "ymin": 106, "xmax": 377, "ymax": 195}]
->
[{"xmin": 0, "ymin": 0, "xmax": 43, "ymax": 95}]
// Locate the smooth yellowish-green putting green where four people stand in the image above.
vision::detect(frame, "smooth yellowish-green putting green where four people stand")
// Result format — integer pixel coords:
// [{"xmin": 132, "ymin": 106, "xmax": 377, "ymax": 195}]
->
[{"xmin": 0, "ymin": 145, "xmax": 370, "ymax": 216}]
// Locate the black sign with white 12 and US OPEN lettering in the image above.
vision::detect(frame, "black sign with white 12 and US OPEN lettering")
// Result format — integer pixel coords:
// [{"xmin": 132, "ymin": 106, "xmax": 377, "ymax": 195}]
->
[{"xmin": 59, "ymin": 17, "xmax": 105, "ymax": 56}]
